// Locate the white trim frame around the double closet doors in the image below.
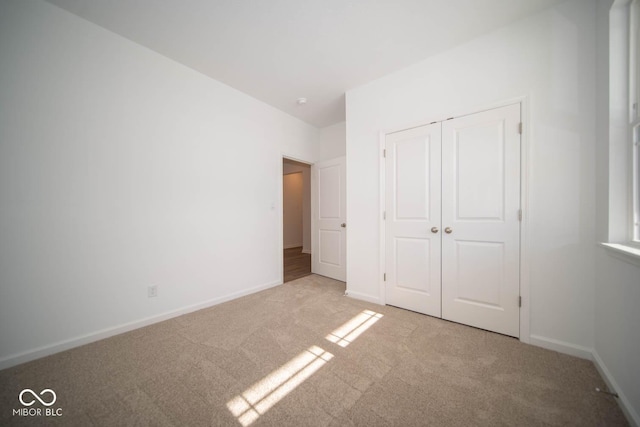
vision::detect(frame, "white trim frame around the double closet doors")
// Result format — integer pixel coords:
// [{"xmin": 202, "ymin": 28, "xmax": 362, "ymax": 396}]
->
[{"xmin": 378, "ymin": 95, "xmax": 531, "ymax": 344}]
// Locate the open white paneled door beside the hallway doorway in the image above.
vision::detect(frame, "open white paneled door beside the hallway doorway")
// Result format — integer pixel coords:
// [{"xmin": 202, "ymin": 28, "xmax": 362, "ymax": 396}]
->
[{"xmin": 311, "ymin": 157, "xmax": 347, "ymax": 282}]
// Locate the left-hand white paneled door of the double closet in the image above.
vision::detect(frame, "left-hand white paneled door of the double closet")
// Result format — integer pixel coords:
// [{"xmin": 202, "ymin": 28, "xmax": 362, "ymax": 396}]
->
[{"xmin": 385, "ymin": 123, "xmax": 441, "ymax": 317}]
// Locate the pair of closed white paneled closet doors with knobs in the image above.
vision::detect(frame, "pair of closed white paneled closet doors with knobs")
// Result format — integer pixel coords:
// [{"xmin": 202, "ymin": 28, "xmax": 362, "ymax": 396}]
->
[{"xmin": 385, "ymin": 104, "xmax": 520, "ymax": 337}]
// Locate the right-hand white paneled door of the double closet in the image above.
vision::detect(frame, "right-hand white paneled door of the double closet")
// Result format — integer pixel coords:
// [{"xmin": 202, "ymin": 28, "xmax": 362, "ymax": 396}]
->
[{"xmin": 442, "ymin": 105, "xmax": 520, "ymax": 337}]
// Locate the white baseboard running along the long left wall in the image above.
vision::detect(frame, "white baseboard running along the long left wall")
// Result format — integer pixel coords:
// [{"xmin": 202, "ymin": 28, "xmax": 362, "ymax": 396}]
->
[{"xmin": 0, "ymin": 280, "xmax": 282, "ymax": 370}]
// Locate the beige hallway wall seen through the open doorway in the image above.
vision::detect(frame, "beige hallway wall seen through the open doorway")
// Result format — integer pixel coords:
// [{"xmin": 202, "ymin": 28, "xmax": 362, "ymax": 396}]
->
[{"xmin": 282, "ymin": 172, "xmax": 304, "ymax": 249}]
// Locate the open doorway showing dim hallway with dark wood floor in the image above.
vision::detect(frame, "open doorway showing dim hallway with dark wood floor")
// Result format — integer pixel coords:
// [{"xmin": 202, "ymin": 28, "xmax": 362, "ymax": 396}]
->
[{"xmin": 282, "ymin": 158, "xmax": 311, "ymax": 283}]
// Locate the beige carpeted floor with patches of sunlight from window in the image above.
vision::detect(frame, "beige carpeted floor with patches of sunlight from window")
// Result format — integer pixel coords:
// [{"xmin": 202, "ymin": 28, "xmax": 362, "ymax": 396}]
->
[{"xmin": 0, "ymin": 275, "xmax": 627, "ymax": 426}]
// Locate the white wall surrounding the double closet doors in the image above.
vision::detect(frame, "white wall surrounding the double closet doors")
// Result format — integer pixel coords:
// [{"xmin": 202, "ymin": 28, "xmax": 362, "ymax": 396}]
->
[{"xmin": 347, "ymin": 0, "xmax": 596, "ymax": 357}]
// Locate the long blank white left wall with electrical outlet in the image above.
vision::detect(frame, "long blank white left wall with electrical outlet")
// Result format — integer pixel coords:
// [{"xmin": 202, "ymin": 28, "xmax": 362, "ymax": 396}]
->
[{"xmin": 0, "ymin": 1, "xmax": 318, "ymax": 368}]
